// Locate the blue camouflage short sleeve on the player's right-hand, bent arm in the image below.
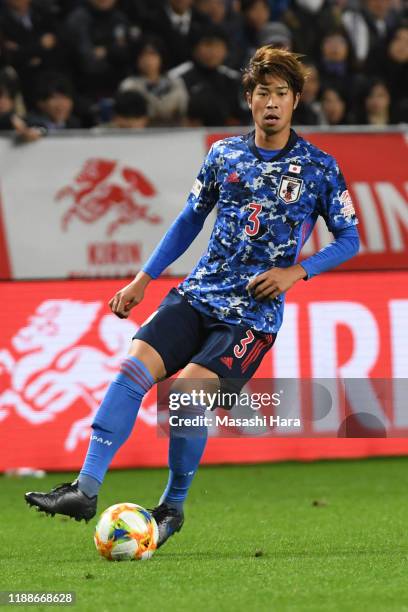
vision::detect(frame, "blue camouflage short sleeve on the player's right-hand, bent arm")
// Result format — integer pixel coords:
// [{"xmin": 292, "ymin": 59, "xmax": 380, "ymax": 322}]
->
[{"xmin": 318, "ymin": 158, "xmax": 358, "ymax": 232}]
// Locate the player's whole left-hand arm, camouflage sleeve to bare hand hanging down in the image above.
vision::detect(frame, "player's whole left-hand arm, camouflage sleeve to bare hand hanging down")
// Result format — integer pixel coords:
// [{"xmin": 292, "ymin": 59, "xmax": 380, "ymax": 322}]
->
[{"xmin": 109, "ymin": 149, "xmax": 218, "ymax": 318}]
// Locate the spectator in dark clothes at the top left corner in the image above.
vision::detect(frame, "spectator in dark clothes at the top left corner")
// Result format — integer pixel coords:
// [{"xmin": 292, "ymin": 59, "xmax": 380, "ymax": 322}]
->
[{"xmin": 0, "ymin": 0, "xmax": 68, "ymax": 105}]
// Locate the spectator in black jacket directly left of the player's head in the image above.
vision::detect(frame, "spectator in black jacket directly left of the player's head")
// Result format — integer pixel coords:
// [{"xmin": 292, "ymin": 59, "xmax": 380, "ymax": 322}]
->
[{"xmin": 169, "ymin": 26, "xmax": 248, "ymax": 125}]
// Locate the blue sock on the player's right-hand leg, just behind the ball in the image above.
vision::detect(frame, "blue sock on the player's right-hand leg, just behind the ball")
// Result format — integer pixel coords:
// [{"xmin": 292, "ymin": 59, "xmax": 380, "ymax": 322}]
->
[{"xmin": 159, "ymin": 408, "xmax": 208, "ymax": 512}]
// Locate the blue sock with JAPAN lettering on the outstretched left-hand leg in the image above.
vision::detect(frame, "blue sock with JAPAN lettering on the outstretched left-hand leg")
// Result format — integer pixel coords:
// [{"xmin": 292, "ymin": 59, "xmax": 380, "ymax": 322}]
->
[{"xmin": 78, "ymin": 357, "xmax": 154, "ymax": 497}]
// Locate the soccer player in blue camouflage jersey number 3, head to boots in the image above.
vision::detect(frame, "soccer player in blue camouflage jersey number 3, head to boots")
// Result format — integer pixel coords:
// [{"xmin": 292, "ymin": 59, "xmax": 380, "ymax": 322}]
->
[{"xmin": 25, "ymin": 46, "xmax": 359, "ymax": 546}]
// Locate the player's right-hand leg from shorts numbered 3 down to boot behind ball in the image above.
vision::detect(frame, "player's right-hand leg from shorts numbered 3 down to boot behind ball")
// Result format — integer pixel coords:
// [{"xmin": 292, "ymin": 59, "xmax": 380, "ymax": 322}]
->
[{"xmin": 153, "ymin": 316, "xmax": 275, "ymax": 545}]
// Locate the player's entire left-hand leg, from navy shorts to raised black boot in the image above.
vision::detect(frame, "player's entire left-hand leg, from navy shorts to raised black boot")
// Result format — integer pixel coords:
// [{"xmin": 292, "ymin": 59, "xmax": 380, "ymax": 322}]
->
[{"xmin": 26, "ymin": 290, "xmax": 200, "ymax": 520}]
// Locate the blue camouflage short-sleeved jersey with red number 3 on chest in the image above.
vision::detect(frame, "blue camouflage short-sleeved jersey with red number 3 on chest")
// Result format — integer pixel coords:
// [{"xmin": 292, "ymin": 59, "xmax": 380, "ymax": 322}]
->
[{"xmin": 178, "ymin": 130, "xmax": 357, "ymax": 333}]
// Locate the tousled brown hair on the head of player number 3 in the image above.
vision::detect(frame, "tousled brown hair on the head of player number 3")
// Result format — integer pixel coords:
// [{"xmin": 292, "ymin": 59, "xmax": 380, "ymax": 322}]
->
[{"xmin": 242, "ymin": 45, "xmax": 307, "ymax": 96}]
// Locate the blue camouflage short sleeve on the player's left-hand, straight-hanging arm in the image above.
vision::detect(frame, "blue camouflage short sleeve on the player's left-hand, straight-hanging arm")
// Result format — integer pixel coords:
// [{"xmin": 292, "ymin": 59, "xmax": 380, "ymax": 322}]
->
[{"xmin": 186, "ymin": 144, "xmax": 219, "ymax": 218}]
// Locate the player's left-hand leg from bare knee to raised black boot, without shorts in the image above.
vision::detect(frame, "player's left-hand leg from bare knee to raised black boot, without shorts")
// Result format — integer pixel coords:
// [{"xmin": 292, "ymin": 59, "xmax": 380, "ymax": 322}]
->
[{"xmin": 25, "ymin": 340, "xmax": 166, "ymax": 520}]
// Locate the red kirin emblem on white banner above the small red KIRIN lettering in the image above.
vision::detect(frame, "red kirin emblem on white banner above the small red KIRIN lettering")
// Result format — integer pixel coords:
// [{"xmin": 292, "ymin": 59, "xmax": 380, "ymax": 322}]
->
[{"xmin": 55, "ymin": 158, "xmax": 162, "ymax": 236}]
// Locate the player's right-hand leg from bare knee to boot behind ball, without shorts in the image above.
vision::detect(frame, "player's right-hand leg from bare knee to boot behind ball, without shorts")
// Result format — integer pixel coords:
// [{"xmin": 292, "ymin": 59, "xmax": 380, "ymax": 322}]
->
[{"xmin": 152, "ymin": 363, "xmax": 219, "ymax": 546}]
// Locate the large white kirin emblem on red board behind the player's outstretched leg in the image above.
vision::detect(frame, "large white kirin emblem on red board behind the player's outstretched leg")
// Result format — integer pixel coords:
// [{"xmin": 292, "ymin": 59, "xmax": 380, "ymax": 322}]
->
[{"xmin": 0, "ymin": 300, "xmax": 156, "ymax": 451}]
